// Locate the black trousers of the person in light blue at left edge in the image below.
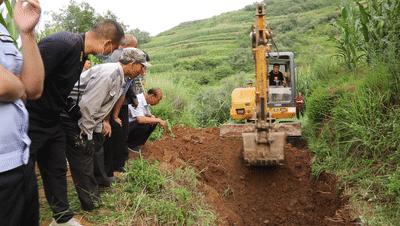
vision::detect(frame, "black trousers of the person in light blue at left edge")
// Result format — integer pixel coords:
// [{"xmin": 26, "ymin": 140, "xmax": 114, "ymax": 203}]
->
[{"xmin": 0, "ymin": 162, "xmax": 39, "ymax": 226}]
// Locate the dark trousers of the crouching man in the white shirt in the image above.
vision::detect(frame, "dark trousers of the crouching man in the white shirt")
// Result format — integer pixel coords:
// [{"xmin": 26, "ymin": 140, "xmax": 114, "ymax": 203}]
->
[{"xmin": 128, "ymin": 121, "xmax": 157, "ymax": 148}]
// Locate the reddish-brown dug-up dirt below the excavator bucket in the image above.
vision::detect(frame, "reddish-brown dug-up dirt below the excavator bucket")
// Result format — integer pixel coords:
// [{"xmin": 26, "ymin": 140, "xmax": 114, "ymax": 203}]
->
[{"xmin": 139, "ymin": 127, "xmax": 350, "ymax": 226}]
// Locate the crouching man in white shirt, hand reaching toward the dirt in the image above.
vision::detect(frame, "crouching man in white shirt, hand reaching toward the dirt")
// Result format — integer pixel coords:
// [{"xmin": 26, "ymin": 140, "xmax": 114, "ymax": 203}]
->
[{"xmin": 128, "ymin": 88, "xmax": 166, "ymax": 151}]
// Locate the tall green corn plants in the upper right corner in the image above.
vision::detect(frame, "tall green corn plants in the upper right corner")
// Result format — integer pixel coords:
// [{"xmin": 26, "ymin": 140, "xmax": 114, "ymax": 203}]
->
[{"xmin": 335, "ymin": 0, "xmax": 400, "ymax": 69}]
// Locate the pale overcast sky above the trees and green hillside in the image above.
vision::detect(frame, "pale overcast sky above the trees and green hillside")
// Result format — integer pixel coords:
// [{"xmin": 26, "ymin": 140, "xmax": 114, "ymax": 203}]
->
[{"xmin": 40, "ymin": 0, "xmax": 256, "ymax": 35}]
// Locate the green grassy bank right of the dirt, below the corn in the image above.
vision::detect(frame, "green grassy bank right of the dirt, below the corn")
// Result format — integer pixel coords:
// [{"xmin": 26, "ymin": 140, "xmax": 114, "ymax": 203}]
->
[{"xmin": 304, "ymin": 63, "xmax": 400, "ymax": 225}]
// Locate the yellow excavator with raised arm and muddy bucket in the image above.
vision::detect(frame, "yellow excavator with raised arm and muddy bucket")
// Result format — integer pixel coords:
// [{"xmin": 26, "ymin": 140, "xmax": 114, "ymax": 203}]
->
[{"xmin": 220, "ymin": 4, "xmax": 301, "ymax": 165}]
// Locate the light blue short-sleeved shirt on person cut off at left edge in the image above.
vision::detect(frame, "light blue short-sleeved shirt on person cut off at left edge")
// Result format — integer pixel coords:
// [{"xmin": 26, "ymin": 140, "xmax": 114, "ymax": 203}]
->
[{"xmin": 0, "ymin": 24, "xmax": 31, "ymax": 173}]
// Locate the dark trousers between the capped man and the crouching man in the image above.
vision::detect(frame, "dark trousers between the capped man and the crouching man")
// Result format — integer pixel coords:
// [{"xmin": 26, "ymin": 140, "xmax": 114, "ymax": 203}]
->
[{"xmin": 104, "ymin": 105, "xmax": 129, "ymax": 176}]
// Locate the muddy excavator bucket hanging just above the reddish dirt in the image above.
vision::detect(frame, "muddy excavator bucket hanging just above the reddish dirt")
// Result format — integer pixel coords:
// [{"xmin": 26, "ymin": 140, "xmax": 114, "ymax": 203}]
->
[{"xmin": 242, "ymin": 132, "xmax": 287, "ymax": 166}]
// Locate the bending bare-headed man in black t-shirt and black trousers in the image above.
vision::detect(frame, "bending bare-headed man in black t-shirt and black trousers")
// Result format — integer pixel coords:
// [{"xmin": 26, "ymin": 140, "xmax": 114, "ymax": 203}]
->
[{"xmin": 27, "ymin": 20, "xmax": 124, "ymax": 226}]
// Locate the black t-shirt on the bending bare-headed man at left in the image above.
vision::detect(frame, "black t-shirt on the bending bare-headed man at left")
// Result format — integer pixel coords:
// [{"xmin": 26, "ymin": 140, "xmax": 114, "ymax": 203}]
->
[{"xmin": 27, "ymin": 32, "xmax": 87, "ymax": 121}]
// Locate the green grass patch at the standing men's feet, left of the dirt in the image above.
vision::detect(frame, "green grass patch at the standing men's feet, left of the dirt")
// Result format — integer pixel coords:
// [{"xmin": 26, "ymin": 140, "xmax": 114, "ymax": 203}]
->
[{"xmin": 41, "ymin": 158, "xmax": 218, "ymax": 226}]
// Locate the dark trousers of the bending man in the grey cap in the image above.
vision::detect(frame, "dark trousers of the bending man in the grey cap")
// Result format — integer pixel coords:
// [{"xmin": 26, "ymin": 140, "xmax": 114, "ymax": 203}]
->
[{"xmin": 63, "ymin": 118, "xmax": 103, "ymax": 211}]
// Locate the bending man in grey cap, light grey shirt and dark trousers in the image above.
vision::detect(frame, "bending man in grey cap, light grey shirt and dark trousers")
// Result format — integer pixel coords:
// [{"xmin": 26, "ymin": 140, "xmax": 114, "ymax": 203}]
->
[{"xmin": 62, "ymin": 48, "xmax": 148, "ymax": 211}]
